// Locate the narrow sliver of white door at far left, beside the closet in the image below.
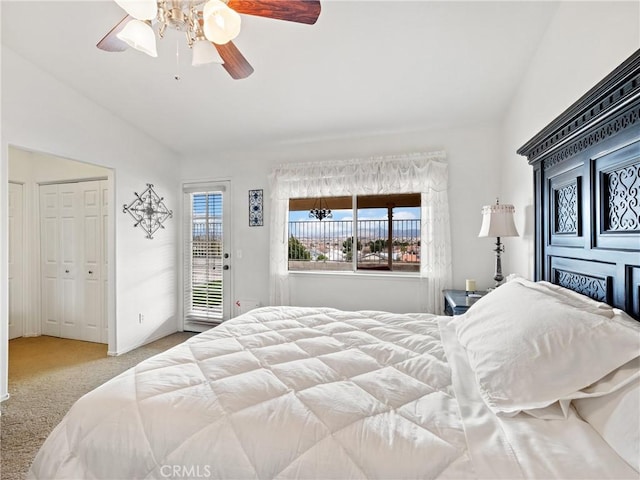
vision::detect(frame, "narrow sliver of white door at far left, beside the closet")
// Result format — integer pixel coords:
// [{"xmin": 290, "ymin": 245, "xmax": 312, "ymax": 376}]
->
[{"xmin": 8, "ymin": 183, "xmax": 25, "ymax": 339}]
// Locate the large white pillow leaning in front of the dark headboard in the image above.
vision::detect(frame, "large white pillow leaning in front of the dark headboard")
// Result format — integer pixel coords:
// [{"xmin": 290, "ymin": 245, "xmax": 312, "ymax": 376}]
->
[{"xmin": 454, "ymin": 278, "xmax": 640, "ymax": 415}]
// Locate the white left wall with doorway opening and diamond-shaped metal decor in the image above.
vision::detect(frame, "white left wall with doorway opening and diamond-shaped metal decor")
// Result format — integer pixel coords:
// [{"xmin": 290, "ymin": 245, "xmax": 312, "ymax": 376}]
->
[{"xmin": 0, "ymin": 46, "xmax": 180, "ymax": 398}]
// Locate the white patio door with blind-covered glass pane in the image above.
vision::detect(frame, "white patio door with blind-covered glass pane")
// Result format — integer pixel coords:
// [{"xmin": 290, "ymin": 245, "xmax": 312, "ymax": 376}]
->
[{"xmin": 183, "ymin": 182, "xmax": 232, "ymax": 331}]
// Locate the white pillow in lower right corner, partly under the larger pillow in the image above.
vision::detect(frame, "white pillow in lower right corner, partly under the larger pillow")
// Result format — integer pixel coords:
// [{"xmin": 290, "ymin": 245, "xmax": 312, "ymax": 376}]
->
[{"xmin": 573, "ymin": 358, "xmax": 640, "ymax": 472}]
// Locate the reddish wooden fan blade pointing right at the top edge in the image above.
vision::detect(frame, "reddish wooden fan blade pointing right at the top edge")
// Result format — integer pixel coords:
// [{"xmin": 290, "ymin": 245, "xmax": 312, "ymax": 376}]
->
[{"xmin": 228, "ymin": 0, "xmax": 320, "ymax": 25}]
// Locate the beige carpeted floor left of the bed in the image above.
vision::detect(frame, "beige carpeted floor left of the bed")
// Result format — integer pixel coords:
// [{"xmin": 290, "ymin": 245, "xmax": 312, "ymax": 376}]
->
[{"xmin": 0, "ymin": 332, "xmax": 194, "ymax": 480}]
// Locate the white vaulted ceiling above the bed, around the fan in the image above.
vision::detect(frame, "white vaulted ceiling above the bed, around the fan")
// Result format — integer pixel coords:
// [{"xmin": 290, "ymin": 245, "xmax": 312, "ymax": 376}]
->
[{"xmin": 2, "ymin": 0, "xmax": 557, "ymax": 156}]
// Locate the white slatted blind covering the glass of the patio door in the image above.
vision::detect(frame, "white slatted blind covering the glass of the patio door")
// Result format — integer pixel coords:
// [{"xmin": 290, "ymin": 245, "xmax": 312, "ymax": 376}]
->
[{"xmin": 184, "ymin": 190, "xmax": 224, "ymax": 323}]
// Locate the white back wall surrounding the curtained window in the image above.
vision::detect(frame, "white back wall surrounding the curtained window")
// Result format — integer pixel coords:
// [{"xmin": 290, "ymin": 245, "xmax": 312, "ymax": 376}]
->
[{"xmin": 181, "ymin": 122, "xmax": 509, "ymax": 312}]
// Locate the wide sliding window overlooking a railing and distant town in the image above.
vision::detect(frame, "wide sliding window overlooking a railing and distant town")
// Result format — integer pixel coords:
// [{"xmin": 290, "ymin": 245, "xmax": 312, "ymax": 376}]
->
[{"xmin": 288, "ymin": 193, "xmax": 420, "ymax": 272}]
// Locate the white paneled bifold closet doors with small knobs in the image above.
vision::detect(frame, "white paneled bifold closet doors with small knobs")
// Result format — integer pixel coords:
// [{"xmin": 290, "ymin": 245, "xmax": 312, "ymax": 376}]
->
[{"xmin": 40, "ymin": 181, "xmax": 106, "ymax": 342}]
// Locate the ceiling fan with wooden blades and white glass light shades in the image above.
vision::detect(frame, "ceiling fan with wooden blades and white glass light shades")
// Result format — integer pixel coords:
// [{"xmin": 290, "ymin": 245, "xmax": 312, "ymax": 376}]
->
[{"xmin": 96, "ymin": 0, "xmax": 320, "ymax": 80}]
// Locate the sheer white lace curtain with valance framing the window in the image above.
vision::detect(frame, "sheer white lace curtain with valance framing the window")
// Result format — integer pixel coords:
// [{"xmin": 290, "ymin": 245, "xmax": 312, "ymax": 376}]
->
[{"xmin": 269, "ymin": 151, "xmax": 451, "ymax": 313}]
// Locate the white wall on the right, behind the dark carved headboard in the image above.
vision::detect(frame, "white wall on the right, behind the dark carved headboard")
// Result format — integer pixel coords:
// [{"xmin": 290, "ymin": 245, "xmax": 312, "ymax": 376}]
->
[{"xmin": 501, "ymin": 2, "xmax": 640, "ymax": 278}]
